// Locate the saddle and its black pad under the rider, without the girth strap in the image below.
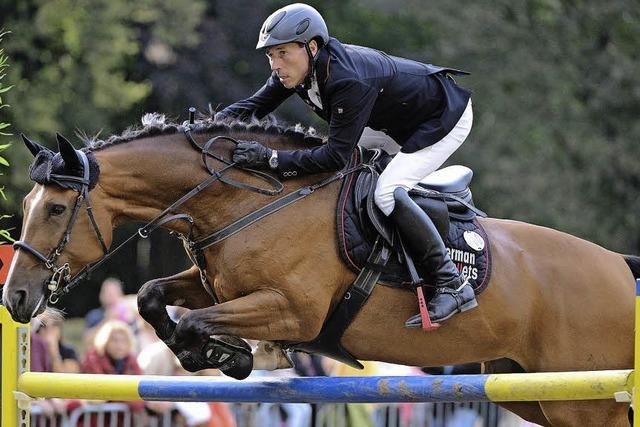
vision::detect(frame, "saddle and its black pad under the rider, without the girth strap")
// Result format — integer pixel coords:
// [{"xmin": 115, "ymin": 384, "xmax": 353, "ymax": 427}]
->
[{"xmin": 336, "ymin": 149, "xmax": 491, "ymax": 294}]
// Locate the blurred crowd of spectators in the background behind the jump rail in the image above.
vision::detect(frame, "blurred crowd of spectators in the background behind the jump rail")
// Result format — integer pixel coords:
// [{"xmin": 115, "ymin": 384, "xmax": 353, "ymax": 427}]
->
[{"xmin": 31, "ymin": 278, "xmax": 521, "ymax": 427}]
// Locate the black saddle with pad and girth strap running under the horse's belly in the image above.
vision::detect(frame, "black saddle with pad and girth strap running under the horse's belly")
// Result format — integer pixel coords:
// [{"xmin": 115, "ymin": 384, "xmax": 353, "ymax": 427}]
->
[{"xmin": 287, "ymin": 148, "xmax": 491, "ymax": 369}]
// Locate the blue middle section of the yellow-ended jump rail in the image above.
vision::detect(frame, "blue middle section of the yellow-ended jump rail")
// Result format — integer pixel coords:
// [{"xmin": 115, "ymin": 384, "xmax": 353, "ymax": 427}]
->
[{"xmin": 138, "ymin": 375, "xmax": 489, "ymax": 403}]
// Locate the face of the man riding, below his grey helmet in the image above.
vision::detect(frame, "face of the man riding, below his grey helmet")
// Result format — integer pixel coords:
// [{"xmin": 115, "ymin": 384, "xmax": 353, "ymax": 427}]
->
[{"xmin": 265, "ymin": 41, "xmax": 317, "ymax": 89}]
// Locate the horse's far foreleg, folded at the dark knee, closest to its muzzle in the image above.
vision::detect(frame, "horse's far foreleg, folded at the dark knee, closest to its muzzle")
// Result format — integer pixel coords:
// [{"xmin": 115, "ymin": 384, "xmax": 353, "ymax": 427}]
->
[{"xmin": 138, "ymin": 267, "xmax": 213, "ymax": 341}]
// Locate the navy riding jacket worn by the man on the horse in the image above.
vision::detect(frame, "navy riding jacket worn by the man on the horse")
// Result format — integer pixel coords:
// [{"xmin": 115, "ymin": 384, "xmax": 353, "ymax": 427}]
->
[{"xmin": 221, "ymin": 38, "xmax": 471, "ymax": 177}]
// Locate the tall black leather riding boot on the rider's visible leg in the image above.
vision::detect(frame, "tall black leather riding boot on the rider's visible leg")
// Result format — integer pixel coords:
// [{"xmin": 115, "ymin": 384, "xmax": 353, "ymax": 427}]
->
[{"xmin": 389, "ymin": 188, "xmax": 478, "ymax": 327}]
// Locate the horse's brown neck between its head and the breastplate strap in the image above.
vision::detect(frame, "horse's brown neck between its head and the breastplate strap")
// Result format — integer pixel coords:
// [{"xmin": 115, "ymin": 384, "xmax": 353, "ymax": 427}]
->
[{"xmin": 95, "ymin": 134, "xmax": 337, "ymax": 233}]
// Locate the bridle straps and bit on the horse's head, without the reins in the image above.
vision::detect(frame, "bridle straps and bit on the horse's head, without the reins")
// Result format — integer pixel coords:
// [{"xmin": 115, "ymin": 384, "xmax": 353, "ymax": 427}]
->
[{"xmin": 13, "ymin": 150, "xmax": 109, "ymax": 304}]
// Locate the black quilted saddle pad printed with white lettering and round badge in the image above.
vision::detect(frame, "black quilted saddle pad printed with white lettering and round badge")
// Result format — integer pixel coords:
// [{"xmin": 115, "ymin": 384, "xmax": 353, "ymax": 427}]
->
[{"xmin": 337, "ymin": 152, "xmax": 491, "ymax": 294}]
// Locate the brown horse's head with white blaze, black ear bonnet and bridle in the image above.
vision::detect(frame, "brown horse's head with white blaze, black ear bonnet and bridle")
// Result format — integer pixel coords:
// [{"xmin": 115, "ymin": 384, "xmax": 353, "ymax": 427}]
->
[{"xmin": 2, "ymin": 135, "xmax": 112, "ymax": 322}]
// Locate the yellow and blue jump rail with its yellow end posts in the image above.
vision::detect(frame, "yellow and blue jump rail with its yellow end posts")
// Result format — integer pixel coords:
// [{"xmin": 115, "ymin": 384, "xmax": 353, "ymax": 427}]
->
[{"xmin": 0, "ymin": 266, "xmax": 640, "ymax": 427}]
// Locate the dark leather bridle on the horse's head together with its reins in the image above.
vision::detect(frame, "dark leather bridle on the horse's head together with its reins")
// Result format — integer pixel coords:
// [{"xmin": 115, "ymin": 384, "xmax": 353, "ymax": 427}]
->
[{"xmin": 13, "ymin": 129, "xmax": 284, "ymax": 304}]
